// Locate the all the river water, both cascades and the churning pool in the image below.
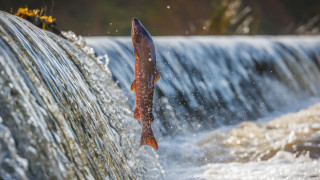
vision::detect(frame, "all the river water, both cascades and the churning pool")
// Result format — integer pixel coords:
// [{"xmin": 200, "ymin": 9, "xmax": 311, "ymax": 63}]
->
[{"xmin": 0, "ymin": 11, "xmax": 320, "ymax": 179}]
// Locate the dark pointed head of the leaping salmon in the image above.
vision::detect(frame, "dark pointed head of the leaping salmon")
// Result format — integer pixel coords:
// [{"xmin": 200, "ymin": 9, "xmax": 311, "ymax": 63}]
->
[{"xmin": 131, "ymin": 18, "xmax": 156, "ymax": 63}]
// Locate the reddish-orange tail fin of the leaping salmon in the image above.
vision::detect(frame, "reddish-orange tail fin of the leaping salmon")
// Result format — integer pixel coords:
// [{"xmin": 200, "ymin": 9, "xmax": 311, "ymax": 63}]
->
[{"xmin": 140, "ymin": 121, "xmax": 158, "ymax": 150}]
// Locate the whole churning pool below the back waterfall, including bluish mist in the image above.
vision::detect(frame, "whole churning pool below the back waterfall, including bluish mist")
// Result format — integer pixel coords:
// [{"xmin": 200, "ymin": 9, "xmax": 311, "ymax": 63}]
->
[{"xmin": 159, "ymin": 99, "xmax": 320, "ymax": 179}]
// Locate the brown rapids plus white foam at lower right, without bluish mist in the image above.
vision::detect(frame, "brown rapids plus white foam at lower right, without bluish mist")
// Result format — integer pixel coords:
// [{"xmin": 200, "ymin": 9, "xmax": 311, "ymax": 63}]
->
[{"xmin": 193, "ymin": 104, "xmax": 320, "ymax": 179}]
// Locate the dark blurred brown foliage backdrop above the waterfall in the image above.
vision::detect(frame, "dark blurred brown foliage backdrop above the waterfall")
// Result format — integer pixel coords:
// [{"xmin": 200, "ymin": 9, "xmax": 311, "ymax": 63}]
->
[{"xmin": 0, "ymin": 0, "xmax": 320, "ymax": 36}]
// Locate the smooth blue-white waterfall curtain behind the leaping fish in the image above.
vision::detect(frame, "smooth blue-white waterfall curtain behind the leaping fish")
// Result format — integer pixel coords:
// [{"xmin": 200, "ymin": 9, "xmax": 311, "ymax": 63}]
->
[{"xmin": 86, "ymin": 36, "xmax": 320, "ymax": 134}]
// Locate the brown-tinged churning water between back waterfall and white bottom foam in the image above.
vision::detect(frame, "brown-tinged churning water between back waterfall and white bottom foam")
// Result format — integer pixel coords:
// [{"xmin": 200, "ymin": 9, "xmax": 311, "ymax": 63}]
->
[{"xmin": 198, "ymin": 104, "xmax": 320, "ymax": 162}]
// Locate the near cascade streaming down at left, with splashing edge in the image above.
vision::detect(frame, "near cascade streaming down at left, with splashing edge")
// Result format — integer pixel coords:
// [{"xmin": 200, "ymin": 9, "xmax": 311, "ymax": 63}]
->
[{"xmin": 0, "ymin": 12, "xmax": 161, "ymax": 179}]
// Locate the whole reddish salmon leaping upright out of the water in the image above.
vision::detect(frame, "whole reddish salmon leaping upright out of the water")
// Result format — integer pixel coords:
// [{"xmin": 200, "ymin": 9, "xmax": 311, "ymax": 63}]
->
[{"xmin": 130, "ymin": 18, "xmax": 160, "ymax": 150}]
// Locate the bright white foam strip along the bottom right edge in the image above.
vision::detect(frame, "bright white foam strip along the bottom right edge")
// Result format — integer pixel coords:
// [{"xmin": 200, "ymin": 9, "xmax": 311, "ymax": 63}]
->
[{"xmin": 195, "ymin": 155, "xmax": 320, "ymax": 180}]
